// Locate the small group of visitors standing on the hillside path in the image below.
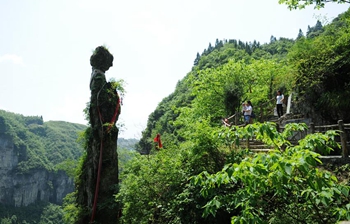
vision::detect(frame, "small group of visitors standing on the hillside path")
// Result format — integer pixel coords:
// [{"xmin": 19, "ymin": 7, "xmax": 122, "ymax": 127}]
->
[{"xmin": 222, "ymin": 90, "xmax": 284, "ymax": 127}]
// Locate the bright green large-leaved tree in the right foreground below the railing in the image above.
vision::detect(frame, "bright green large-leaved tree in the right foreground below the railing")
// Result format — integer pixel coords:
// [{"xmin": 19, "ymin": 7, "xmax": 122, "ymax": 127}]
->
[{"xmin": 192, "ymin": 123, "xmax": 350, "ymax": 223}]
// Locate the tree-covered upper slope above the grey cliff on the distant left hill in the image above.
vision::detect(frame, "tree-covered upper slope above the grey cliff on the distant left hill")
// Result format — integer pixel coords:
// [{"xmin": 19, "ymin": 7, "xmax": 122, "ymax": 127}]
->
[{"xmin": 0, "ymin": 110, "xmax": 86, "ymax": 173}]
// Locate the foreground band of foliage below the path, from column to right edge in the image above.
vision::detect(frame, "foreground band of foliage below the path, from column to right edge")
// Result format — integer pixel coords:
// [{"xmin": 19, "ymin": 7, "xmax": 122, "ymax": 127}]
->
[{"xmin": 117, "ymin": 120, "xmax": 350, "ymax": 223}]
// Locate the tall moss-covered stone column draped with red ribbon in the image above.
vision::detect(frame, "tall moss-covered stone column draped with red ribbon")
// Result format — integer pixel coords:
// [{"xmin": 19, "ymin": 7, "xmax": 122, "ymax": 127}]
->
[{"xmin": 76, "ymin": 46, "xmax": 120, "ymax": 224}]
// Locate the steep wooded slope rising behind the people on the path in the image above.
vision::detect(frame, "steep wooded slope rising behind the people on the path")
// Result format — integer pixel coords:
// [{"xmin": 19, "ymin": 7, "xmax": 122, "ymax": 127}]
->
[{"xmin": 136, "ymin": 11, "xmax": 350, "ymax": 154}]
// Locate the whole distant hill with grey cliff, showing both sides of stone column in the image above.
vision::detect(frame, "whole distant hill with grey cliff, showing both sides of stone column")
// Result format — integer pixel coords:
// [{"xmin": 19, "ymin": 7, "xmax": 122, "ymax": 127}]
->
[{"xmin": 0, "ymin": 110, "xmax": 137, "ymax": 224}]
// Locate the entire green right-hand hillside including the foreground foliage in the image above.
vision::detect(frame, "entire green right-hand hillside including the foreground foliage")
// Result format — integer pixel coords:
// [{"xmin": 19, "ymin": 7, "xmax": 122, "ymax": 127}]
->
[{"xmin": 116, "ymin": 7, "xmax": 350, "ymax": 224}]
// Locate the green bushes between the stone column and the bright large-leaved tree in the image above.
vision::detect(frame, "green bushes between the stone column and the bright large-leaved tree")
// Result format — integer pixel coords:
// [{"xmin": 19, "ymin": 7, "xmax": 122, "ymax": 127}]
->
[{"xmin": 117, "ymin": 116, "xmax": 234, "ymax": 224}]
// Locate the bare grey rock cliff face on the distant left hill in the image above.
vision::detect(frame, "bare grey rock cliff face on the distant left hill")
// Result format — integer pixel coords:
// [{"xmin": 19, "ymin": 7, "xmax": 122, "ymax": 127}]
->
[{"xmin": 0, "ymin": 133, "xmax": 74, "ymax": 207}]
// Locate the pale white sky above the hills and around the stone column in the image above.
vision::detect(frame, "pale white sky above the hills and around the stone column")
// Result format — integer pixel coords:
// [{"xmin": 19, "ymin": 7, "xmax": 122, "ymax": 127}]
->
[{"xmin": 0, "ymin": 0, "xmax": 350, "ymax": 139}]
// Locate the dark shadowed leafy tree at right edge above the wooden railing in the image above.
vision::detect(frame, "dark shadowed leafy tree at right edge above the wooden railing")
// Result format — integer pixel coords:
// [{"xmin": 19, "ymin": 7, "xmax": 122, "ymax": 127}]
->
[{"xmin": 289, "ymin": 8, "xmax": 350, "ymax": 122}]
